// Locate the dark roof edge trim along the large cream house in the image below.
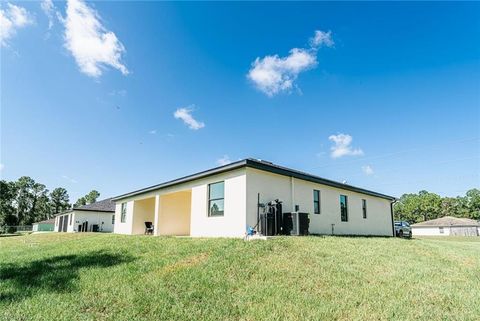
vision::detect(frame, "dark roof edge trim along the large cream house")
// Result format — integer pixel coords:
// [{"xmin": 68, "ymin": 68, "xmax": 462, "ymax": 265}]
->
[{"xmin": 112, "ymin": 158, "xmax": 396, "ymax": 201}]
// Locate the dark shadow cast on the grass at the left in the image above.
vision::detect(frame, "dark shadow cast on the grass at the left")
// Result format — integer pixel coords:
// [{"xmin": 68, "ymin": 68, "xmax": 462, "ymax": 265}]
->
[{"xmin": 0, "ymin": 251, "xmax": 134, "ymax": 302}]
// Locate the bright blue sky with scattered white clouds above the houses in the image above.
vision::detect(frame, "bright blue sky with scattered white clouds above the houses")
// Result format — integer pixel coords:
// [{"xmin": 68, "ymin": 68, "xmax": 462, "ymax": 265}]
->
[{"xmin": 1, "ymin": 0, "xmax": 480, "ymax": 201}]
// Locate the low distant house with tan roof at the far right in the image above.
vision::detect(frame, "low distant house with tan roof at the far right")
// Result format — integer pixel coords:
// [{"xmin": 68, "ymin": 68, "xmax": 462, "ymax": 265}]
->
[{"xmin": 412, "ymin": 216, "xmax": 480, "ymax": 236}]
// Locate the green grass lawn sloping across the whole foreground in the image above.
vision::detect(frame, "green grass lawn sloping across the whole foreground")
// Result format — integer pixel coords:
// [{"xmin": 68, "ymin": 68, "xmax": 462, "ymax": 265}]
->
[{"xmin": 0, "ymin": 233, "xmax": 480, "ymax": 320}]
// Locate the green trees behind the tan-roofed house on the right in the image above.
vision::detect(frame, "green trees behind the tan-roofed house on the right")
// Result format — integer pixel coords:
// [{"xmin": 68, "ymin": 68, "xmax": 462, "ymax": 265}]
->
[{"xmin": 394, "ymin": 188, "xmax": 480, "ymax": 224}]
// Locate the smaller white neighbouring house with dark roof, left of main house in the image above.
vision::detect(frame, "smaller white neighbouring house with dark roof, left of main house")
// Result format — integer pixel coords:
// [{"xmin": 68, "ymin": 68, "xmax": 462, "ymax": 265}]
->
[{"xmin": 55, "ymin": 198, "xmax": 115, "ymax": 232}]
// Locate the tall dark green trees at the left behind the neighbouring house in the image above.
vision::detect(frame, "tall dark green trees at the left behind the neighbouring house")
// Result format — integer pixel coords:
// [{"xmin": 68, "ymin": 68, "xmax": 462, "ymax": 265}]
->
[{"xmin": 0, "ymin": 176, "xmax": 100, "ymax": 227}]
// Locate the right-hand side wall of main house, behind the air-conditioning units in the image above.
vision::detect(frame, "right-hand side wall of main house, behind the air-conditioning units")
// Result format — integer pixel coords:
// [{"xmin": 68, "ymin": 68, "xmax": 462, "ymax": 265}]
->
[{"xmin": 247, "ymin": 168, "xmax": 393, "ymax": 236}]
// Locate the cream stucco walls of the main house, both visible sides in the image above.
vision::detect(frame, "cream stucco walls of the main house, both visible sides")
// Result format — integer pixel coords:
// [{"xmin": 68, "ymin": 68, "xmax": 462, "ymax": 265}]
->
[{"xmin": 115, "ymin": 168, "xmax": 393, "ymax": 237}]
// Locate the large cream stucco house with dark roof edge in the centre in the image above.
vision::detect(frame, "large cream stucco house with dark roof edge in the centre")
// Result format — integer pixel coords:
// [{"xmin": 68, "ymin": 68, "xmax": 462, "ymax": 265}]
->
[{"xmin": 113, "ymin": 158, "xmax": 395, "ymax": 237}]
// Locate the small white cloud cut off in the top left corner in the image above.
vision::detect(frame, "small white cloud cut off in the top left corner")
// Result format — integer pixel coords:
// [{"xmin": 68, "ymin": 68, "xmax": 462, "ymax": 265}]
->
[{"xmin": 0, "ymin": 3, "xmax": 33, "ymax": 46}]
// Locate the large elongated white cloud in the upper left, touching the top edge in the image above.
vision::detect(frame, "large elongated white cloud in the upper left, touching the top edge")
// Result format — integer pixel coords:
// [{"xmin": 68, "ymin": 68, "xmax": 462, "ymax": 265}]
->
[{"xmin": 63, "ymin": 0, "xmax": 128, "ymax": 77}]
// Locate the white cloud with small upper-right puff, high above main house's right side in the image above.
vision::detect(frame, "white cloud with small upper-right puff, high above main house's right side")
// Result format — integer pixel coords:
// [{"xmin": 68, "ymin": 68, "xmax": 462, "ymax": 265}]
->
[{"xmin": 247, "ymin": 30, "xmax": 333, "ymax": 97}]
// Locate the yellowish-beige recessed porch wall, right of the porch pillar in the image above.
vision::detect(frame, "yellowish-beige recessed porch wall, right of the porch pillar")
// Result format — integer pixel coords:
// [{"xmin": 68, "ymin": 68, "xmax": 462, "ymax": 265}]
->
[{"xmin": 160, "ymin": 191, "xmax": 192, "ymax": 235}]
